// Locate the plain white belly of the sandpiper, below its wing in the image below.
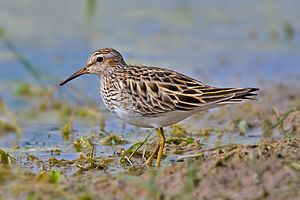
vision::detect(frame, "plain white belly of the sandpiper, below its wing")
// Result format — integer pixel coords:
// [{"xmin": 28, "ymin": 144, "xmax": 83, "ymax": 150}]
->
[{"xmin": 114, "ymin": 108, "xmax": 194, "ymax": 128}]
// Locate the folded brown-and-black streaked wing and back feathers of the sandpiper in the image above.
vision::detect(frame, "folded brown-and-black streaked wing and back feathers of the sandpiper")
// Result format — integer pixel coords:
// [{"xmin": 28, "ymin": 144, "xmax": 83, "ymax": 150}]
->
[{"xmin": 119, "ymin": 66, "xmax": 258, "ymax": 116}]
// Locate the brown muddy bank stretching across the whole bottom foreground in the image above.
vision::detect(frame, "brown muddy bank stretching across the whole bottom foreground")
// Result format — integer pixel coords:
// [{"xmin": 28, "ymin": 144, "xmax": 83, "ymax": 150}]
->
[{"xmin": 0, "ymin": 138, "xmax": 300, "ymax": 199}]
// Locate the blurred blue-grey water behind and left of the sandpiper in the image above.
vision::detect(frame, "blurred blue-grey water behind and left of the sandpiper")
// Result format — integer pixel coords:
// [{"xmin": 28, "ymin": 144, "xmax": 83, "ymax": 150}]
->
[{"xmin": 0, "ymin": 0, "xmax": 300, "ymax": 169}]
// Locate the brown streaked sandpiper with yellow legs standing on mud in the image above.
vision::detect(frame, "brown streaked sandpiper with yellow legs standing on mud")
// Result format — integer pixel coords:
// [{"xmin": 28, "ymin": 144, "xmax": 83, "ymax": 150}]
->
[{"xmin": 60, "ymin": 48, "xmax": 258, "ymax": 166}]
